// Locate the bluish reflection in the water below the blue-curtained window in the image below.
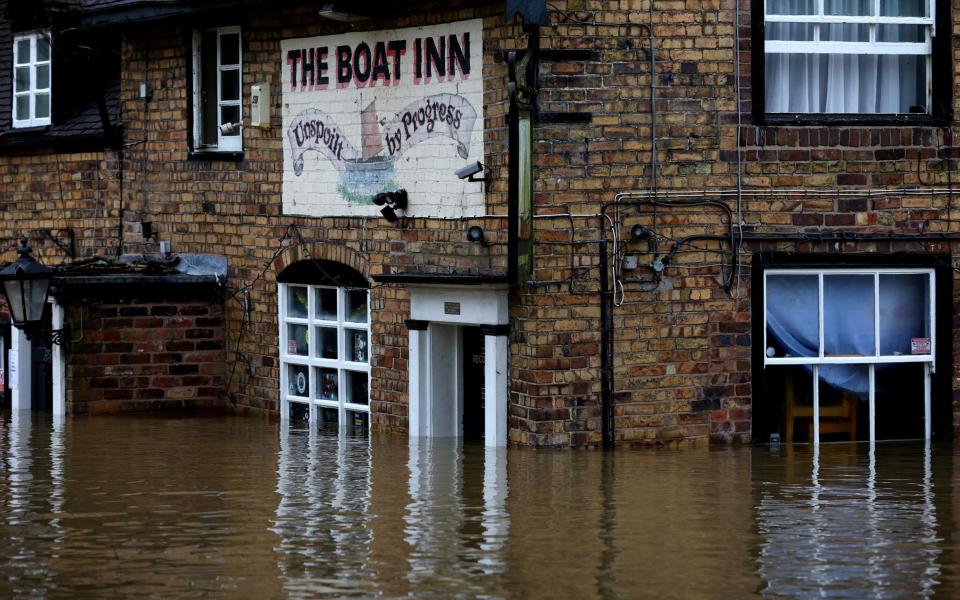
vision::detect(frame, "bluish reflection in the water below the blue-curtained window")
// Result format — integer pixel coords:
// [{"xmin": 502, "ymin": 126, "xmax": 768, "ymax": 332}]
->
[{"xmin": 755, "ymin": 443, "xmax": 942, "ymax": 597}]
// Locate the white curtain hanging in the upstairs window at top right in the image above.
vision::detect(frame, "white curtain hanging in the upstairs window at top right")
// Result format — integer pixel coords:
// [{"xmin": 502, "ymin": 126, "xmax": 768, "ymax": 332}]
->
[{"xmin": 765, "ymin": 0, "xmax": 926, "ymax": 114}]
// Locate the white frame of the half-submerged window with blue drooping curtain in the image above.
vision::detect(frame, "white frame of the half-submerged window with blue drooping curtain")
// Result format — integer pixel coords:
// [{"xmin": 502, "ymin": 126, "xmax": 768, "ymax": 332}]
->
[{"xmin": 763, "ymin": 269, "xmax": 937, "ymax": 444}]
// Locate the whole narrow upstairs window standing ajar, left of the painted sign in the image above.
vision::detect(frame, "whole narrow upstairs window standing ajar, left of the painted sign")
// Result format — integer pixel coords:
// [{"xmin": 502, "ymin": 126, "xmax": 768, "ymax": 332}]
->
[{"xmin": 193, "ymin": 27, "xmax": 243, "ymax": 152}]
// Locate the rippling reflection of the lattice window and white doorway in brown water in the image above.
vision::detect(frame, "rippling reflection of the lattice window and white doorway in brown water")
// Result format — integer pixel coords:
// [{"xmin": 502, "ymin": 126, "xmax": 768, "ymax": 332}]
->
[{"xmin": 272, "ymin": 426, "xmax": 510, "ymax": 596}]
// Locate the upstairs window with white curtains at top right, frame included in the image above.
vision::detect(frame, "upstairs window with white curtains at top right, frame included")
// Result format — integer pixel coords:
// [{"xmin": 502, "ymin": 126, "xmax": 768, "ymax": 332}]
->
[{"xmin": 763, "ymin": 0, "xmax": 936, "ymax": 114}]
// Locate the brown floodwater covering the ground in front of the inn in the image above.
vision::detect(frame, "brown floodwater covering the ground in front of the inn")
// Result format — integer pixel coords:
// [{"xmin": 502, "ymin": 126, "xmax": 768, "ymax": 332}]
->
[{"xmin": 0, "ymin": 415, "xmax": 960, "ymax": 598}]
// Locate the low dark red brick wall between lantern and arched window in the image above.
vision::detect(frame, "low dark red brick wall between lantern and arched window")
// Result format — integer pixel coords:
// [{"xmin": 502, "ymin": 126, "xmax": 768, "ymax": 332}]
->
[{"xmin": 66, "ymin": 298, "xmax": 228, "ymax": 414}]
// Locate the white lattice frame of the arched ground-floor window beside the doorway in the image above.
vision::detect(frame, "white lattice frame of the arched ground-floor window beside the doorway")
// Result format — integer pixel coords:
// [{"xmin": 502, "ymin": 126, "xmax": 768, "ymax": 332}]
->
[{"xmin": 278, "ymin": 283, "xmax": 372, "ymax": 431}]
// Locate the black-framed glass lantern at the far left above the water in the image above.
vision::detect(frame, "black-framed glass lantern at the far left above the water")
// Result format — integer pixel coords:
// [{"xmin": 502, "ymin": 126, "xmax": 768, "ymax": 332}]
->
[{"xmin": 0, "ymin": 237, "xmax": 53, "ymax": 339}]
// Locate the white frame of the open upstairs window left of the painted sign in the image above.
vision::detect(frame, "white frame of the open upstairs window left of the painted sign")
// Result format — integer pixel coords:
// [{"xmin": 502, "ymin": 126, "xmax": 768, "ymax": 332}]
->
[{"xmin": 193, "ymin": 27, "xmax": 243, "ymax": 152}]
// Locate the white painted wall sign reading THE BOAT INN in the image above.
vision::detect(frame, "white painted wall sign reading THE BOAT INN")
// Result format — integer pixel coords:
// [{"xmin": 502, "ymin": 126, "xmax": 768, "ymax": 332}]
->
[{"xmin": 281, "ymin": 19, "xmax": 485, "ymax": 218}]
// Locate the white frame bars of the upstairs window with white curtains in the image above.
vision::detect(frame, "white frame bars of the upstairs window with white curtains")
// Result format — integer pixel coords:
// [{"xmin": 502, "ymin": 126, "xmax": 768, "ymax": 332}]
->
[{"xmin": 763, "ymin": 0, "xmax": 937, "ymax": 115}]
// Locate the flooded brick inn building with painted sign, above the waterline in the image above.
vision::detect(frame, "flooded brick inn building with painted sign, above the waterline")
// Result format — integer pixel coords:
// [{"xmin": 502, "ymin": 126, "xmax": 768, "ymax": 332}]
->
[{"xmin": 0, "ymin": 0, "xmax": 960, "ymax": 446}]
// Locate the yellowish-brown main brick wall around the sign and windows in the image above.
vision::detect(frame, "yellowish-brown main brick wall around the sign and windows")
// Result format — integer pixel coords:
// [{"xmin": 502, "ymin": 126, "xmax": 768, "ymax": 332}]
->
[{"xmin": 0, "ymin": 0, "xmax": 960, "ymax": 446}]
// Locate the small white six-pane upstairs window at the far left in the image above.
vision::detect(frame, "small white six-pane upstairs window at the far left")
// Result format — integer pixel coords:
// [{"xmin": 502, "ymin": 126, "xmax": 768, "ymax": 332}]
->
[{"xmin": 13, "ymin": 32, "xmax": 51, "ymax": 127}]
